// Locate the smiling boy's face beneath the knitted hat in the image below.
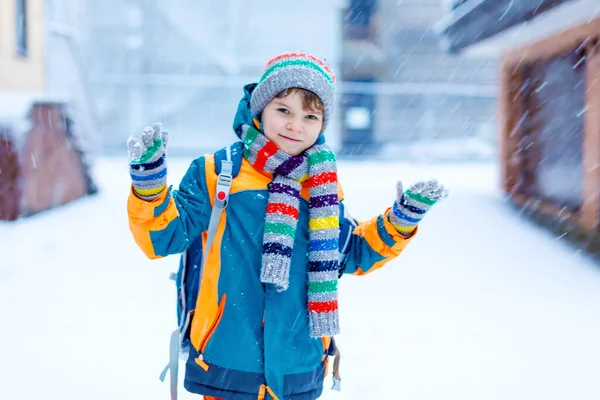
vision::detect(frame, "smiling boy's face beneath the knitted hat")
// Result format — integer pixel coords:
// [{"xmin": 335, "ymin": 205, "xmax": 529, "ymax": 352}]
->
[{"xmin": 262, "ymin": 90, "xmax": 323, "ymax": 156}]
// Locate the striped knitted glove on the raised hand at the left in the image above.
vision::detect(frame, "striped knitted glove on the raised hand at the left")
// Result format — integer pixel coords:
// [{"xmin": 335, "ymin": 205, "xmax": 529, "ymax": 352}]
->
[{"xmin": 127, "ymin": 123, "xmax": 169, "ymax": 201}]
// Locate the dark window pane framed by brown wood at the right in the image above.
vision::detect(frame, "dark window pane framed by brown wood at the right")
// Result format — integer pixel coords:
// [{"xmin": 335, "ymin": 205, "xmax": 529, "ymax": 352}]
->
[{"xmin": 521, "ymin": 53, "xmax": 587, "ymax": 210}]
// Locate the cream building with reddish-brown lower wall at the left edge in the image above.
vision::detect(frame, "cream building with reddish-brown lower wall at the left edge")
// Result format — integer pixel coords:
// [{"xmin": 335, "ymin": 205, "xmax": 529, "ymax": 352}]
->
[{"xmin": 0, "ymin": 0, "xmax": 96, "ymax": 220}]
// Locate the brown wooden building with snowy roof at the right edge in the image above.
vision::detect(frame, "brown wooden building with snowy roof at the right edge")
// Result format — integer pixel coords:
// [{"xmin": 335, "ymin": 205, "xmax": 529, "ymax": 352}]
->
[{"xmin": 439, "ymin": 0, "xmax": 600, "ymax": 252}]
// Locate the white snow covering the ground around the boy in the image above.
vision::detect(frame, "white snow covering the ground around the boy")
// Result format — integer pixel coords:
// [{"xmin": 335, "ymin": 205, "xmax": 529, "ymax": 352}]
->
[{"xmin": 0, "ymin": 158, "xmax": 600, "ymax": 400}]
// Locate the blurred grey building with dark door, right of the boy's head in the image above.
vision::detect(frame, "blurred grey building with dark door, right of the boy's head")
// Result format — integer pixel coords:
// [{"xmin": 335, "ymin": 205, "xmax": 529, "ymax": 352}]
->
[{"xmin": 341, "ymin": 0, "xmax": 498, "ymax": 160}]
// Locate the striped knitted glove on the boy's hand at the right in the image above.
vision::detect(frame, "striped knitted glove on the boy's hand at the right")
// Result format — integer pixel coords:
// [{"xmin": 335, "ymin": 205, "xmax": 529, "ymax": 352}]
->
[{"xmin": 389, "ymin": 179, "xmax": 448, "ymax": 237}]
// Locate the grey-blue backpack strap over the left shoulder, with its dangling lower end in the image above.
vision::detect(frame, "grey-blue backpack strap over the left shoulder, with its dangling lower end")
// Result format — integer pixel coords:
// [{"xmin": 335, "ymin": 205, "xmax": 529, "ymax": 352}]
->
[{"xmin": 160, "ymin": 142, "xmax": 238, "ymax": 400}]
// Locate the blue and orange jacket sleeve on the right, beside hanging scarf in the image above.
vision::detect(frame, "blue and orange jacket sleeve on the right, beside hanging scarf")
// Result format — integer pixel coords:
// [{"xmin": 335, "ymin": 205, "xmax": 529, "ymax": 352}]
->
[{"xmin": 340, "ymin": 201, "xmax": 418, "ymax": 275}]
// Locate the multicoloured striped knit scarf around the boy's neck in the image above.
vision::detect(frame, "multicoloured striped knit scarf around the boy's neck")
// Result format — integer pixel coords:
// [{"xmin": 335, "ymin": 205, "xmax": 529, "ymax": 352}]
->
[{"xmin": 241, "ymin": 125, "xmax": 339, "ymax": 337}]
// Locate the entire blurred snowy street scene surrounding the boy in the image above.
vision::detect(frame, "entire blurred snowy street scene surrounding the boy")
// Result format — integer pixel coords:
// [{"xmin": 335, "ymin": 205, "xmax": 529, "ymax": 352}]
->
[{"xmin": 0, "ymin": 0, "xmax": 600, "ymax": 400}]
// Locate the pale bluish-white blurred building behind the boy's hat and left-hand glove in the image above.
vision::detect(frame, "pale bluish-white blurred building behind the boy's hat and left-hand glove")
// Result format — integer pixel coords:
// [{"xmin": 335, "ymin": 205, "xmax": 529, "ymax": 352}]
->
[{"xmin": 81, "ymin": 0, "xmax": 344, "ymax": 155}]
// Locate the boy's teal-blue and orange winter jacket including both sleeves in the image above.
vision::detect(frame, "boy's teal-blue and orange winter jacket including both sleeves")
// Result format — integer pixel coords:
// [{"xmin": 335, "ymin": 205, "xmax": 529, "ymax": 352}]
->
[{"xmin": 127, "ymin": 84, "xmax": 414, "ymax": 400}]
